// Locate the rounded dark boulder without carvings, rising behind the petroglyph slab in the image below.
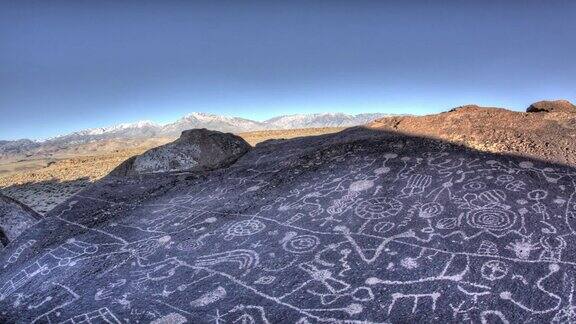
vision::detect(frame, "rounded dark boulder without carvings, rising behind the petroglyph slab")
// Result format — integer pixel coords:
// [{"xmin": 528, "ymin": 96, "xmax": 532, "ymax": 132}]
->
[{"xmin": 111, "ymin": 129, "xmax": 250, "ymax": 176}]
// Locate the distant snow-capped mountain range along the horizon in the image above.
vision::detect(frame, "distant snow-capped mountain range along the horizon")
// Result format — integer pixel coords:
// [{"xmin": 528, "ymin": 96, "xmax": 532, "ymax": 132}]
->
[{"xmin": 0, "ymin": 112, "xmax": 392, "ymax": 158}]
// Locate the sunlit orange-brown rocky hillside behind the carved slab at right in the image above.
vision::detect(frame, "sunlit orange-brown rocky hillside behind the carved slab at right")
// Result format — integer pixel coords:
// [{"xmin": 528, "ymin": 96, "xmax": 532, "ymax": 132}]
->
[{"xmin": 369, "ymin": 100, "xmax": 576, "ymax": 166}]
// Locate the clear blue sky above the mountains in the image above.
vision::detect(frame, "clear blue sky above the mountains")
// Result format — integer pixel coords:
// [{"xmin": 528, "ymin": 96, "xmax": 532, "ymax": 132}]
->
[{"xmin": 0, "ymin": 0, "xmax": 576, "ymax": 139}]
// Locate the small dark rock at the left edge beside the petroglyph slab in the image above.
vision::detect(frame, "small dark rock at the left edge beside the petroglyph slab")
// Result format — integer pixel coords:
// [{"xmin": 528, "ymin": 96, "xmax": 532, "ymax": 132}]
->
[{"xmin": 0, "ymin": 194, "xmax": 42, "ymax": 249}]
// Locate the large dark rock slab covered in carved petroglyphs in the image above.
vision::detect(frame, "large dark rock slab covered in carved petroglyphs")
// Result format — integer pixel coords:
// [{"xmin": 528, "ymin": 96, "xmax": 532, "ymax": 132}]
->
[{"xmin": 0, "ymin": 129, "xmax": 576, "ymax": 323}]
